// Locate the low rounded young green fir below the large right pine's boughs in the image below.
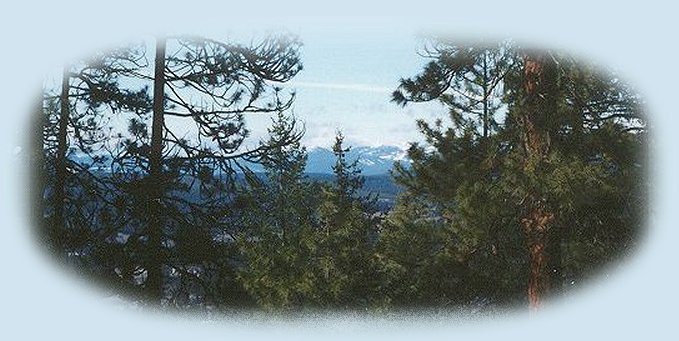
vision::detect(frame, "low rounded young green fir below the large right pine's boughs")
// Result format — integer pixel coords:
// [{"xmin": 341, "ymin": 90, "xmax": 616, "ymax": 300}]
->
[{"xmin": 376, "ymin": 193, "xmax": 462, "ymax": 309}]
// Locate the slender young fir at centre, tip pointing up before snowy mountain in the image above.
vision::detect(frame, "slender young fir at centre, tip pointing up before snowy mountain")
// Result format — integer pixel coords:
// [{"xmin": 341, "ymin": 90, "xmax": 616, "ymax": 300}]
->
[{"xmin": 317, "ymin": 132, "xmax": 378, "ymax": 309}]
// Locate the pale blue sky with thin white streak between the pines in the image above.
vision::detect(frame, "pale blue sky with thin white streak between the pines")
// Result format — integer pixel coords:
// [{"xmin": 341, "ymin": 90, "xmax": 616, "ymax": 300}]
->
[{"xmin": 250, "ymin": 31, "xmax": 445, "ymax": 147}]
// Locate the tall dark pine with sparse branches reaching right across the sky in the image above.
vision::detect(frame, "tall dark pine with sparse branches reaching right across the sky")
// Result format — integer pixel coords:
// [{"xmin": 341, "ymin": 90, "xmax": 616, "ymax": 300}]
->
[{"xmin": 114, "ymin": 36, "xmax": 301, "ymax": 302}]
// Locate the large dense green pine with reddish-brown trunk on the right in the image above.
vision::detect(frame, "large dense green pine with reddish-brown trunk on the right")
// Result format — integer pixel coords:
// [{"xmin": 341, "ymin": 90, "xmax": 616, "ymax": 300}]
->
[{"xmin": 394, "ymin": 38, "xmax": 644, "ymax": 308}]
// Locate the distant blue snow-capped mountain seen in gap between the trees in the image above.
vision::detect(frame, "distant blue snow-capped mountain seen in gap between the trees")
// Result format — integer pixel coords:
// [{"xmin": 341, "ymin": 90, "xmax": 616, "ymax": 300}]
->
[{"xmin": 306, "ymin": 146, "xmax": 409, "ymax": 175}]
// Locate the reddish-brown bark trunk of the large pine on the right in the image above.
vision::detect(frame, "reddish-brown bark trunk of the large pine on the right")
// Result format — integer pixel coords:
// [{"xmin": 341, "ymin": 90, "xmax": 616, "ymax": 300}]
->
[{"xmin": 519, "ymin": 53, "xmax": 557, "ymax": 311}]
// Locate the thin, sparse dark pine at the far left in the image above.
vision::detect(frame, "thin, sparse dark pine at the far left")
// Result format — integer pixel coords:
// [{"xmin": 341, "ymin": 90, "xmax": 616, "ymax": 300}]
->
[{"xmin": 34, "ymin": 46, "xmax": 150, "ymax": 262}]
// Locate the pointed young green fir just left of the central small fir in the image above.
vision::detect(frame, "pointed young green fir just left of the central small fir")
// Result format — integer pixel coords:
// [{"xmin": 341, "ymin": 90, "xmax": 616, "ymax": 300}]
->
[{"xmin": 237, "ymin": 114, "xmax": 318, "ymax": 310}]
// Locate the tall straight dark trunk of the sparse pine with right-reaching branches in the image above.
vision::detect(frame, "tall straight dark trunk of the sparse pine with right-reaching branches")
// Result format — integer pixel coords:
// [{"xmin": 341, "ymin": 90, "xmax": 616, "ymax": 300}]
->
[{"xmin": 145, "ymin": 37, "xmax": 165, "ymax": 303}]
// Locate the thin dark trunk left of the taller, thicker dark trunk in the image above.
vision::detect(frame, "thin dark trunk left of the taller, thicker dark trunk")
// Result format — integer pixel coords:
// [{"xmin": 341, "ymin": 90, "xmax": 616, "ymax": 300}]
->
[{"xmin": 49, "ymin": 66, "xmax": 71, "ymax": 250}]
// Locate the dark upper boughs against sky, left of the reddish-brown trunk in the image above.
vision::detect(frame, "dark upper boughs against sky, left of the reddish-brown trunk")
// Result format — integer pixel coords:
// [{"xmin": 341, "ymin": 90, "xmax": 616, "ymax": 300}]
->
[{"xmin": 392, "ymin": 39, "xmax": 516, "ymax": 137}]
